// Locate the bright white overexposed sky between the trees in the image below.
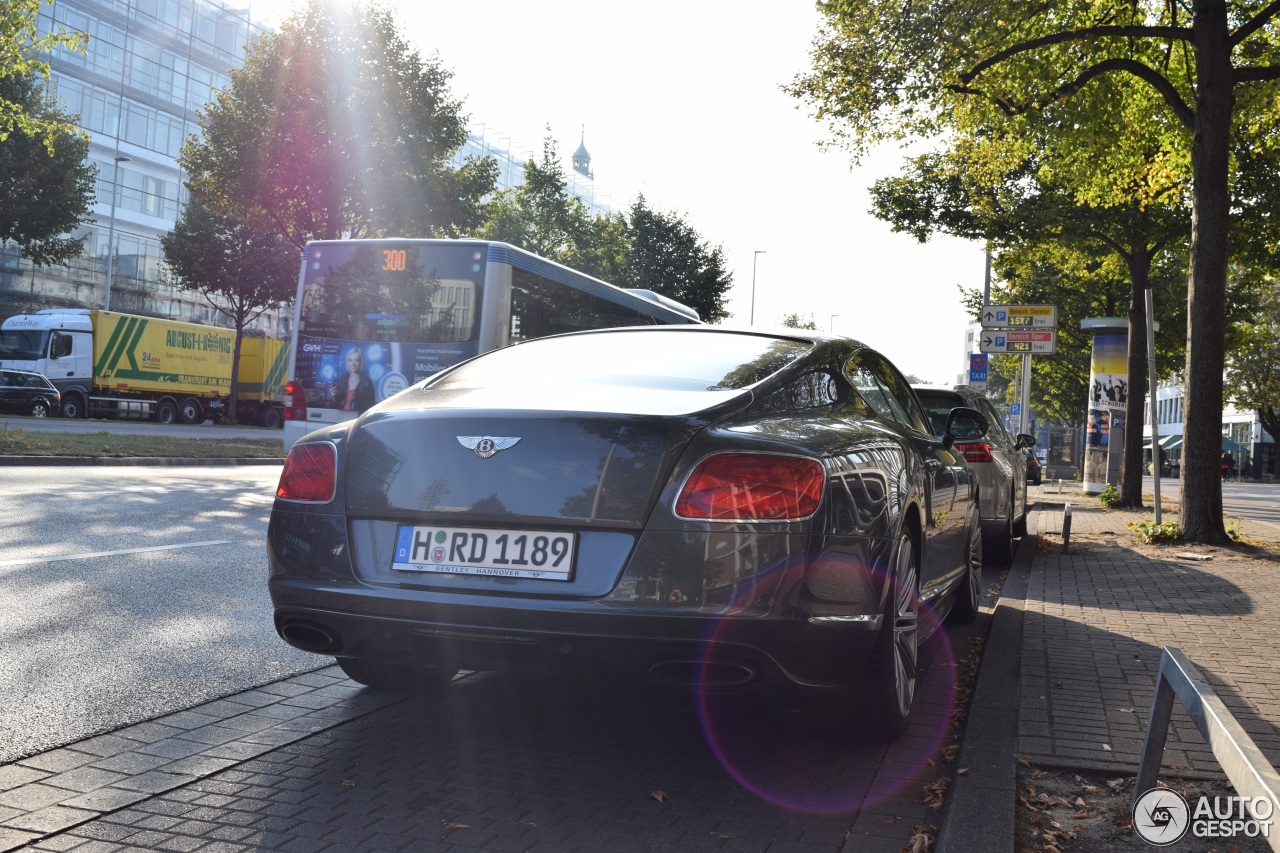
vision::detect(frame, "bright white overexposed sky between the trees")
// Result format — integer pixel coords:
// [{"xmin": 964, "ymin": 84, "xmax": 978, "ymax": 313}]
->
[{"xmin": 252, "ymin": 0, "xmax": 986, "ymax": 384}]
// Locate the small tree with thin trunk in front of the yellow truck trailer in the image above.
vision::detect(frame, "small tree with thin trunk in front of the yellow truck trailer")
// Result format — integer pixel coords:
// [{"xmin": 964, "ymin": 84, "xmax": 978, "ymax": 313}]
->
[{"xmin": 160, "ymin": 199, "xmax": 298, "ymax": 423}]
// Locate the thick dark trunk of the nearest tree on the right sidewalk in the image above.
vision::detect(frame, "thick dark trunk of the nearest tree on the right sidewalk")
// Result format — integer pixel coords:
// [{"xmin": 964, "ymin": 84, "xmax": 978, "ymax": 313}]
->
[{"xmin": 1181, "ymin": 0, "xmax": 1234, "ymax": 544}]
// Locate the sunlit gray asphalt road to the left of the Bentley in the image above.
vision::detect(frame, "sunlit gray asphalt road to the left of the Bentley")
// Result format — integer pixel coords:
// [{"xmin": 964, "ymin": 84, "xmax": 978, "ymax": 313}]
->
[{"xmin": 0, "ymin": 465, "xmax": 317, "ymax": 763}]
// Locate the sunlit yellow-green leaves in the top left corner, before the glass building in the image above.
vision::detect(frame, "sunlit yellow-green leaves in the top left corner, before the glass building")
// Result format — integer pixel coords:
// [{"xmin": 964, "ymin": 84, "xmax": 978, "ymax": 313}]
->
[{"xmin": 0, "ymin": 0, "xmax": 88, "ymax": 143}]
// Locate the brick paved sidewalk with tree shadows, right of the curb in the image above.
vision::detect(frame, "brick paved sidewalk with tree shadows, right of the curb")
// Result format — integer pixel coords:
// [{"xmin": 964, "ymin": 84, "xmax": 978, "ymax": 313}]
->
[{"xmin": 1016, "ymin": 494, "xmax": 1280, "ymax": 775}]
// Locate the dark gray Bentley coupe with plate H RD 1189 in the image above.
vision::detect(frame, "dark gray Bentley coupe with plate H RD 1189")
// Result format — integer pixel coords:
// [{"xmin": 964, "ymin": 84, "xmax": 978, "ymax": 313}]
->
[{"xmin": 269, "ymin": 327, "xmax": 986, "ymax": 738}]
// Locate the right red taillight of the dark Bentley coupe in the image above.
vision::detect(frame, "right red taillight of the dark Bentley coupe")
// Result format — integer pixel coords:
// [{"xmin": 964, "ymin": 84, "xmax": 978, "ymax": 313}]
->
[{"xmin": 676, "ymin": 453, "xmax": 827, "ymax": 521}]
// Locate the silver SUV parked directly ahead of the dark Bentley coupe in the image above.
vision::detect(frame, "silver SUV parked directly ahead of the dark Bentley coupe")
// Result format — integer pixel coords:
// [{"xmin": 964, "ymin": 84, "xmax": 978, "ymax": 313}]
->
[{"xmin": 913, "ymin": 386, "xmax": 1036, "ymax": 566}]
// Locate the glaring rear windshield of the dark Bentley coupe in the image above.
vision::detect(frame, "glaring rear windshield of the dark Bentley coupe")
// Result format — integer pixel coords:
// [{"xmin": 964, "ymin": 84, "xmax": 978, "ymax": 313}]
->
[{"xmin": 430, "ymin": 330, "xmax": 813, "ymax": 391}]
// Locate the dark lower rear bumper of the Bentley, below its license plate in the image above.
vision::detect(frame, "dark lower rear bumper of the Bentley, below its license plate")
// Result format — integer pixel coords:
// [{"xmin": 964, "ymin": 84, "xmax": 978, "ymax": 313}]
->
[{"xmin": 271, "ymin": 581, "xmax": 879, "ymax": 693}]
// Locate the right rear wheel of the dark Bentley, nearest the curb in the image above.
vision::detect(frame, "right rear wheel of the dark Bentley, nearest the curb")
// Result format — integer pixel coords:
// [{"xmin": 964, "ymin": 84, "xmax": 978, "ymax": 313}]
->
[{"xmin": 858, "ymin": 532, "xmax": 920, "ymax": 742}]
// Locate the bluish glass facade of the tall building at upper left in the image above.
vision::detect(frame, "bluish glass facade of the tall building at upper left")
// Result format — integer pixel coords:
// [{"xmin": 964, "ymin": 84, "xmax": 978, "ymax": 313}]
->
[{"xmin": 0, "ymin": 0, "xmax": 287, "ymax": 334}]
